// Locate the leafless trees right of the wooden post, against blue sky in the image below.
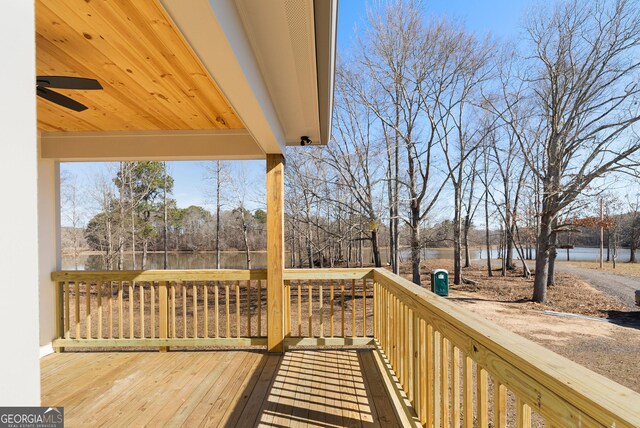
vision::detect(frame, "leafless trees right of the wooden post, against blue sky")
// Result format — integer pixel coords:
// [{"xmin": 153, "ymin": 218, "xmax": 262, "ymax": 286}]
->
[{"xmin": 286, "ymin": 0, "xmax": 640, "ymax": 302}]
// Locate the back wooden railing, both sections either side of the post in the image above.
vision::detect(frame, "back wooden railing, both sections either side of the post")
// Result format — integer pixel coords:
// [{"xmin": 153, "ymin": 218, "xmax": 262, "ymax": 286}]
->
[{"xmin": 52, "ymin": 269, "xmax": 373, "ymax": 350}]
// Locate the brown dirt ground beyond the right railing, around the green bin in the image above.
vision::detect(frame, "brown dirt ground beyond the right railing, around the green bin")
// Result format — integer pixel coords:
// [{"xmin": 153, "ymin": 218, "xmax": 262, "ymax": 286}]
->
[{"xmin": 401, "ymin": 260, "xmax": 640, "ymax": 392}]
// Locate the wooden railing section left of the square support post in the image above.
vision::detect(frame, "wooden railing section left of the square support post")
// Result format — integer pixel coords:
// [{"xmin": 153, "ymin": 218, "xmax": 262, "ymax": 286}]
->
[{"xmin": 52, "ymin": 270, "xmax": 266, "ymax": 349}]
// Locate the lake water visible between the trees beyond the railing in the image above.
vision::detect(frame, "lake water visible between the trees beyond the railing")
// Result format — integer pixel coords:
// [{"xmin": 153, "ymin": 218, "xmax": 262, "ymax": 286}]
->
[{"xmin": 62, "ymin": 247, "xmax": 629, "ymax": 270}]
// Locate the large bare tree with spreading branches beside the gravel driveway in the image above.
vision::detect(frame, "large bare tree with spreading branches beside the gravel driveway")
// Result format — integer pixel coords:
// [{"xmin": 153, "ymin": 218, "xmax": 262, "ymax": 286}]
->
[{"xmin": 502, "ymin": 0, "xmax": 640, "ymax": 302}]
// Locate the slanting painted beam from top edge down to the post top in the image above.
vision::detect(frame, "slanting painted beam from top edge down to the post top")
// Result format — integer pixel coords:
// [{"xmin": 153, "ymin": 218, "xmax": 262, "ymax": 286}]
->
[{"xmin": 161, "ymin": 0, "xmax": 285, "ymax": 153}]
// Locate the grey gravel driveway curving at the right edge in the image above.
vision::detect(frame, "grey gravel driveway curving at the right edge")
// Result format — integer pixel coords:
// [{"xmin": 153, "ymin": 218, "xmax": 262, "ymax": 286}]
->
[{"xmin": 556, "ymin": 263, "xmax": 640, "ymax": 309}]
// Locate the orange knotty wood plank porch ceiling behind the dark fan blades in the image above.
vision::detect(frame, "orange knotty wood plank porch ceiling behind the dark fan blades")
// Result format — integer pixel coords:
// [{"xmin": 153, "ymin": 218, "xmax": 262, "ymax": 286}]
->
[{"xmin": 36, "ymin": 0, "xmax": 244, "ymax": 132}]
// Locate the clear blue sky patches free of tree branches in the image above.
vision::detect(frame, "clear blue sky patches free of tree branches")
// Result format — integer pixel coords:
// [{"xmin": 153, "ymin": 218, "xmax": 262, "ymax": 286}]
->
[{"xmin": 61, "ymin": 0, "xmax": 532, "ymax": 221}]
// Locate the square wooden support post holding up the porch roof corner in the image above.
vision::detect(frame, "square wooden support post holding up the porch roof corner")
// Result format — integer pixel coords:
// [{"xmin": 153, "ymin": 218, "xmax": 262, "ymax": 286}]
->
[{"xmin": 267, "ymin": 154, "xmax": 285, "ymax": 352}]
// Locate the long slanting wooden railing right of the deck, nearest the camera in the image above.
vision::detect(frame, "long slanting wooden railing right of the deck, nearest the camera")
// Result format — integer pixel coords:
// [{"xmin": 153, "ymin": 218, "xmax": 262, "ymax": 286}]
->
[{"xmin": 373, "ymin": 269, "xmax": 640, "ymax": 428}]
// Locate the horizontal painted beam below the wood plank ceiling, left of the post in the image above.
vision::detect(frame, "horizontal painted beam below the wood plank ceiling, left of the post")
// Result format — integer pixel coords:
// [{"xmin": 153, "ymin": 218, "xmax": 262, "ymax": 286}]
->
[{"xmin": 40, "ymin": 129, "xmax": 265, "ymax": 162}]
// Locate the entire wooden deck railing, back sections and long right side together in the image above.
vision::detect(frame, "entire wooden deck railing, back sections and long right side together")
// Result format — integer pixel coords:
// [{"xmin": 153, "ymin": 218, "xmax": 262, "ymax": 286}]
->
[{"xmin": 52, "ymin": 269, "xmax": 640, "ymax": 428}]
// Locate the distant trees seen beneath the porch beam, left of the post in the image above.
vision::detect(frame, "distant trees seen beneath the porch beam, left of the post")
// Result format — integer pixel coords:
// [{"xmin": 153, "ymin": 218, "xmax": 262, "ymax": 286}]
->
[{"xmin": 61, "ymin": 161, "xmax": 266, "ymax": 270}]
